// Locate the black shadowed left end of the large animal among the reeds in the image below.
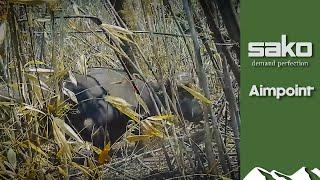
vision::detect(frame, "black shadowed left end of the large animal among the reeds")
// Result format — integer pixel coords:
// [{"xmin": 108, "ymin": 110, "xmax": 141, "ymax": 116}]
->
[{"xmin": 63, "ymin": 75, "xmax": 127, "ymax": 148}]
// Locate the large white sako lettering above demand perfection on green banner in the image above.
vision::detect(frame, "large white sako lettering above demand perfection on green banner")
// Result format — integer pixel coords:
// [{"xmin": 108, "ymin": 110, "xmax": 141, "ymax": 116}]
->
[{"xmin": 248, "ymin": 35, "xmax": 312, "ymax": 57}]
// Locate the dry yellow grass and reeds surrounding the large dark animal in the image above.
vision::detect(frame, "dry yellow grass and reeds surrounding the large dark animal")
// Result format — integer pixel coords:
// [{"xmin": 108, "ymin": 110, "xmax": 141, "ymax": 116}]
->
[{"xmin": 0, "ymin": 0, "xmax": 238, "ymax": 179}]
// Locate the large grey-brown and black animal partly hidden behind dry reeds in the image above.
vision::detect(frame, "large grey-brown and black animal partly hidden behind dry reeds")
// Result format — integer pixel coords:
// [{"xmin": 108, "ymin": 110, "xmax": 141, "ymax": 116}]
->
[{"xmin": 64, "ymin": 68, "xmax": 203, "ymax": 148}]
